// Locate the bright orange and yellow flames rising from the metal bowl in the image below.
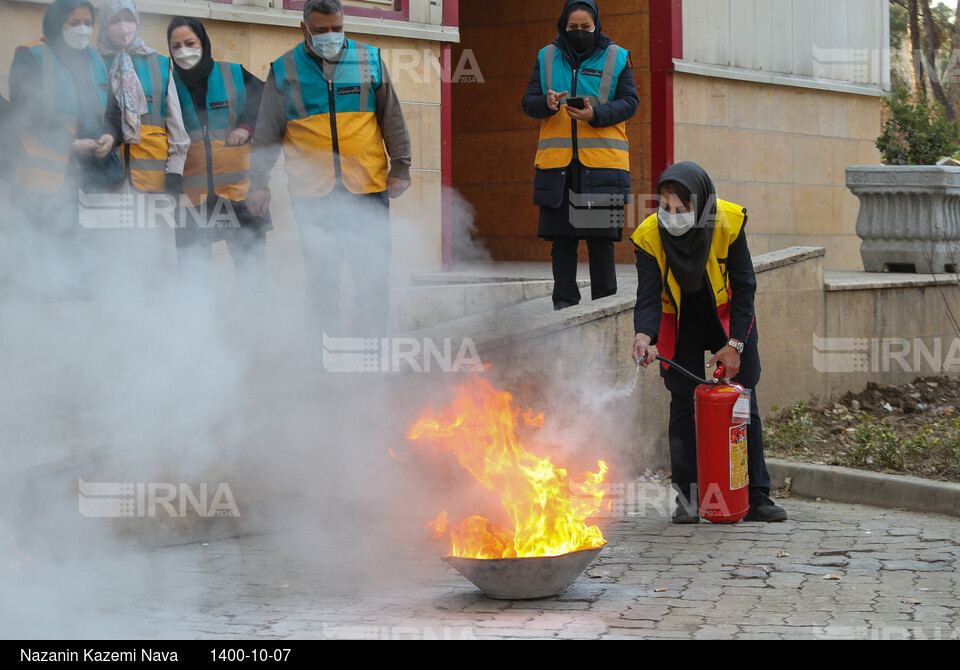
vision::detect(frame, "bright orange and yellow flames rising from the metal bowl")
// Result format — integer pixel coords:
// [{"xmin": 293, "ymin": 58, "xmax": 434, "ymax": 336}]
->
[{"xmin": 409, "ymin": 376, "xmax": 609, "ymax": 558}]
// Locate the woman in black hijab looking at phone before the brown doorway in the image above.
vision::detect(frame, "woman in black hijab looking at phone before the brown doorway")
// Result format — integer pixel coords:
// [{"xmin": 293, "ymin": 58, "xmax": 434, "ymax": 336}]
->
[{"xmin": 523, "ymin": 0, "xmax": 640, "ymax": 310}]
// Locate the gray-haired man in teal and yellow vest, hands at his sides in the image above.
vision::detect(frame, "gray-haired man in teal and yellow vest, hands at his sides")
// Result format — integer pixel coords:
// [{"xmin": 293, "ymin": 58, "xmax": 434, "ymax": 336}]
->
[{"xmin": 247, "ymin": 0, "xmax": 411, "ymax": 337}]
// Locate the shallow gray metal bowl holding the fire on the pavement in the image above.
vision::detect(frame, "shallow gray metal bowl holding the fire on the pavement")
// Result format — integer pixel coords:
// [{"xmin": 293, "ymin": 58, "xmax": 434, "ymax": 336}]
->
[{"xmin": 443, "ymin": 545, "xmax": 606, "ymax": 600}]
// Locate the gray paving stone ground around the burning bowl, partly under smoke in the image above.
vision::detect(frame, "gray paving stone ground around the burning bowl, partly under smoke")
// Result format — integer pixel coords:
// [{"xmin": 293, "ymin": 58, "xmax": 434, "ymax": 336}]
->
[{"xmin": 5, "ymin": 490, "xmax": 960, "ymax": 640}]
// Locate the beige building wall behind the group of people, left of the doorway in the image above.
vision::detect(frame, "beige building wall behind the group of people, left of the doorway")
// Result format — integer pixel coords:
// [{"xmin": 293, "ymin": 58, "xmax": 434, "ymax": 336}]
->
[{"xmin": 0, "ymin": 0, "xmax": 442, "ymax": 287}]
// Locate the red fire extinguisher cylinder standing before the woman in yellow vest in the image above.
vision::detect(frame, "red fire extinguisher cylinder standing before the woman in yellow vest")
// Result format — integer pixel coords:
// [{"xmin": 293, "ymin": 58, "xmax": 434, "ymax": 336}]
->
[{"xmin": 694, "ymin": 363, "xmax": 750, "ymax": 523}]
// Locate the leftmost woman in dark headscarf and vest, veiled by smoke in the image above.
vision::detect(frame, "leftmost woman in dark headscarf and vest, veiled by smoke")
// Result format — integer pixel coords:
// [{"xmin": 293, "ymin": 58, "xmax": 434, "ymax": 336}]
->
[{"xmin": 10, "ymin": 0, "xmax": 123, "ymax": 297}]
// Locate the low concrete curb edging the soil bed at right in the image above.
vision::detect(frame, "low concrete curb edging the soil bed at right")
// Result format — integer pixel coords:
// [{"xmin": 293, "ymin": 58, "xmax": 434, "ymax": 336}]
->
[{"xmin": 767, "ymin": 459, "xmax": 960, "ymax": 517}]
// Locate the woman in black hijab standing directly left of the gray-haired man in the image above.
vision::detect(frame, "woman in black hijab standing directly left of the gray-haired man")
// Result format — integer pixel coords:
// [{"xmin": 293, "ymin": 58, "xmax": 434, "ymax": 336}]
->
[{"xmin": 167, "ymin": 16, "xmax": 273, "ymax": 291}]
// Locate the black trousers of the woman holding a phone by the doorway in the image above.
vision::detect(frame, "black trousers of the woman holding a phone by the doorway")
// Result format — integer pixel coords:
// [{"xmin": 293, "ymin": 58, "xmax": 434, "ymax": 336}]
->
[{"xmin": 552, "ymin": 236, "xmax": 617, "ymax": 310}]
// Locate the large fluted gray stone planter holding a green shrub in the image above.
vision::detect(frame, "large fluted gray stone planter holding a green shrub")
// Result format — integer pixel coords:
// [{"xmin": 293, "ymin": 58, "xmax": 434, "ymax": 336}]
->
[{"xmin": 847, "ymin": 165, "xmax": 960, "ymax": 273}]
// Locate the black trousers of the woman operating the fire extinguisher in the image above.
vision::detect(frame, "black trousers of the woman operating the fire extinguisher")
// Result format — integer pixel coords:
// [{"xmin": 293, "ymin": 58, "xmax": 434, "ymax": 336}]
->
[{"xmin": 661, "ymin": 303, "xmax": 770, "ymax": 507}]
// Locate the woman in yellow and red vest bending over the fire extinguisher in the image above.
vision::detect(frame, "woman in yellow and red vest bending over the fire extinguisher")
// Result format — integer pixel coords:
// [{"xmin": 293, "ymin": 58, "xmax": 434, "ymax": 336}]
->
[{"xmin": 632, "ymin": 162, "xmax": 787, "ymax": 523}]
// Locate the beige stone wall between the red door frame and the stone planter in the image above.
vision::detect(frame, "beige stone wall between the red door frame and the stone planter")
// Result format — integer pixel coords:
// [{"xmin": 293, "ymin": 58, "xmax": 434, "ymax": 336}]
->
[{"xmin": 674, "ymin": 72, "xmax": 881, "ymax": 270}]
